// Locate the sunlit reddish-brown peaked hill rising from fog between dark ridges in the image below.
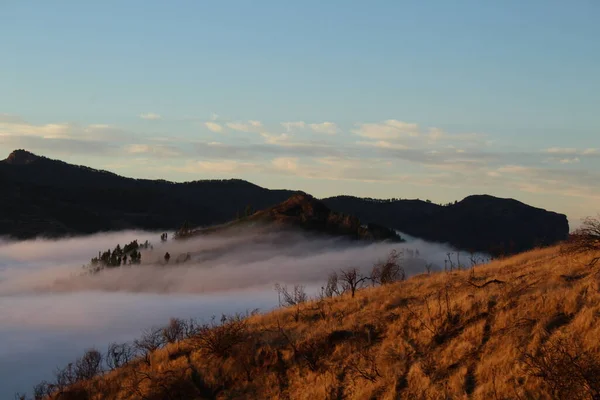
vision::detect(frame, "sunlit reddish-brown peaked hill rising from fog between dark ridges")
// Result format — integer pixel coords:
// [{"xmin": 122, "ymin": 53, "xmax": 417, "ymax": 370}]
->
[{"xmin": 187, "ymin": 193, "xmax": 402, "ymax": 242}]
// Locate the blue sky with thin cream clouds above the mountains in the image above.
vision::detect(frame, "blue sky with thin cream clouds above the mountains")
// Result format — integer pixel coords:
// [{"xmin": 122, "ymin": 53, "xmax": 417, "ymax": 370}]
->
[{"xmin": 0, "ymin": 0, "xmax": 600, "ymax": 226}]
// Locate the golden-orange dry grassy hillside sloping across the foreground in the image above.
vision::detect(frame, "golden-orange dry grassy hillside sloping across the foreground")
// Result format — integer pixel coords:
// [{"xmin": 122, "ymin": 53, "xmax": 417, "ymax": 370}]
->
[{"xmin": 31, "ymin": 247, "xmax": 600, "ymax": 399}]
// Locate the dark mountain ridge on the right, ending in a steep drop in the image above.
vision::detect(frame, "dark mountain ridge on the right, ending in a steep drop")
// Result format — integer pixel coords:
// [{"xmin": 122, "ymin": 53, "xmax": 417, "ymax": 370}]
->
[{"xmin": 324, "ymin": 195, "xmax": 569, "ymax": 255}]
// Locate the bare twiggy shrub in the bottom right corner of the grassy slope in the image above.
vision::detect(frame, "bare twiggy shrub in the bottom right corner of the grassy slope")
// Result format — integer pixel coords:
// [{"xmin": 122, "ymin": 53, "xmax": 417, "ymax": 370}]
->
[{"xmin": 522, "ymin": 336, "xmax": 600, "ymax": 400}]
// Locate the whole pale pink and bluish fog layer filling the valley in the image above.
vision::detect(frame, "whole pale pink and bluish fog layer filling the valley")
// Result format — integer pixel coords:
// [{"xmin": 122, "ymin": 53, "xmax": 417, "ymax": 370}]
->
[{"xmin": 0, "ymin": 230, "xmax": 488, "ymax": 399}]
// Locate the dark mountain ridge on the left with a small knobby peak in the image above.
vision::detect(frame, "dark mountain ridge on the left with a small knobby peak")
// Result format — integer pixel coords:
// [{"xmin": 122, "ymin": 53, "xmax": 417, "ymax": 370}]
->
[{"xmin": 0, "ymin": 150, "xmax": 295, "ymax": 238}]
